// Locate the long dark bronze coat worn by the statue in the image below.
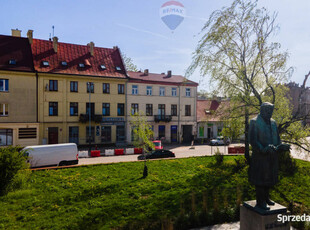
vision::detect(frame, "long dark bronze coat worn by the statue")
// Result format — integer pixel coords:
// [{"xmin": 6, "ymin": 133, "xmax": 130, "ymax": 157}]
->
[{"xmin": 249, "ymin": 115, "xmax": 281, "ymax": 187}]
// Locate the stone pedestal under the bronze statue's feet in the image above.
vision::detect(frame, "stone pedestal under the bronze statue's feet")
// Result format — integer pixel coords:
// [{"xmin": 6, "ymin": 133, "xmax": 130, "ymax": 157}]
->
[{"xmin": 240, "ymin": 200, "xmax": 290, "ymax": 230}]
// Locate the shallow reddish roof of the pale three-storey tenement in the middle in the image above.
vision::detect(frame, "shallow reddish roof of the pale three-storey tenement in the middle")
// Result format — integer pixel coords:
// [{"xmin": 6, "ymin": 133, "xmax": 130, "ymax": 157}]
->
[{"xmin": 128, "ymin": 71, "xmax": 198, "ymax": 86}]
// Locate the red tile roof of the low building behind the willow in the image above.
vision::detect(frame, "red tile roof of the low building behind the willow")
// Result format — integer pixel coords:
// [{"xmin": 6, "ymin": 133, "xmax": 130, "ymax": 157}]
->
[{"xmin": 197, "ymin": 100, "xmax": 230, "ymax": 122}]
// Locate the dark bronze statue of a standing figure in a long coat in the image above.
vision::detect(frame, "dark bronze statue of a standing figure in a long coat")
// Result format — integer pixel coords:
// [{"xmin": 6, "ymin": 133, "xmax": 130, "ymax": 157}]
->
[{"xmin": 249, "ymin": 102, "xmax": 290, "ymax": 210}]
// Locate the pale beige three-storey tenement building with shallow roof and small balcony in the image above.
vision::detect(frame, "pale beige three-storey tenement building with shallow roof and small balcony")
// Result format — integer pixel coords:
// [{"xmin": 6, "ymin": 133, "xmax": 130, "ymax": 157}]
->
[{"xmin": 126, "ymin": 69, "xmax": 198, "ymax": 143}]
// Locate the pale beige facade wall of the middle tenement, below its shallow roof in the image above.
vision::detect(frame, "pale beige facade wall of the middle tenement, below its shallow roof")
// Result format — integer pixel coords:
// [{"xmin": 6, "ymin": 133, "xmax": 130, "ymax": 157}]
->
[{"xmin": 126, "ymin": 81, "xmax": 197, "ymax": 143}]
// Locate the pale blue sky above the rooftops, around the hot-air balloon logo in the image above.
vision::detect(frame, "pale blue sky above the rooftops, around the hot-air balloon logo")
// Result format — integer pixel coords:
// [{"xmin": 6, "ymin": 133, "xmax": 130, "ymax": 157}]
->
[{"xmin": 0, "ymin": 0, "xmax": 310, "ymax": 91}]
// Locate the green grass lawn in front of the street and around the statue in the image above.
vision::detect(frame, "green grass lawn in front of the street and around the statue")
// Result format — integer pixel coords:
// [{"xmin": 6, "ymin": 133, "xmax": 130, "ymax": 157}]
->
[{"xmin": 0, "ymin": 156, "xmax": 310, "ymax": 229}]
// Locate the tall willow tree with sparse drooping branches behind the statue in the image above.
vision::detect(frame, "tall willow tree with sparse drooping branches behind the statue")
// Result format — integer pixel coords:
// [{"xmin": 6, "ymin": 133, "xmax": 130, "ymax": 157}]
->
[{"xmin": 187, "ymin": 0, "xmax": 296, "ymax": 160}]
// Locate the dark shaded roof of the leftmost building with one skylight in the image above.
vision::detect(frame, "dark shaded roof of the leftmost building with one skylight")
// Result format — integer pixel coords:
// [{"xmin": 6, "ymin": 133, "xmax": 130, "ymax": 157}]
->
[{"xmin": 0, "ymin": 35, "xmax": 33, "ymax": 72}]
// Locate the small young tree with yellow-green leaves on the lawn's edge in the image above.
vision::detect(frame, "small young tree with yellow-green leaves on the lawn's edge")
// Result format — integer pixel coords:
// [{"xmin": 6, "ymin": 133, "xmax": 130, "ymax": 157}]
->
[{"xmin": 130, "ymin": 112, "xmax": 154, "ymax": 152}]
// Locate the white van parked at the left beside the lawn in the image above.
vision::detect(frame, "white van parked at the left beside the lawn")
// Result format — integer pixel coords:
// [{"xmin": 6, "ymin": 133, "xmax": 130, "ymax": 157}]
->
[{"xmin": 24, "ymin": 143, "xmax": 79, "ymax": 168}]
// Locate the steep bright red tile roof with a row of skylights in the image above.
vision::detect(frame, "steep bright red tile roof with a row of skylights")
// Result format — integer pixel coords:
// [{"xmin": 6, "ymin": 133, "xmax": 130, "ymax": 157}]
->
[{"xmin": 31, "ymin": 39, "xmax": 127, "ymax": 78}]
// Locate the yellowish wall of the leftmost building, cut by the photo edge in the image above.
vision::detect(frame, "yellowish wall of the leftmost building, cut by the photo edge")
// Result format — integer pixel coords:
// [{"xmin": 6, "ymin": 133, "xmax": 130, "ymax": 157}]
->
[{"xmin": 0, "ymin": 71, "xmax": 39, "ymax": 146}]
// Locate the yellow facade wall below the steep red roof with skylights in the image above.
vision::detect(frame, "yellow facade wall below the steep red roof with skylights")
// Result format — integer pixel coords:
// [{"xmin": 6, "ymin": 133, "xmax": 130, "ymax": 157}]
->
[{"xmin": 39, "ymin": 73, "xmax": 126, "ymax": 144}]
